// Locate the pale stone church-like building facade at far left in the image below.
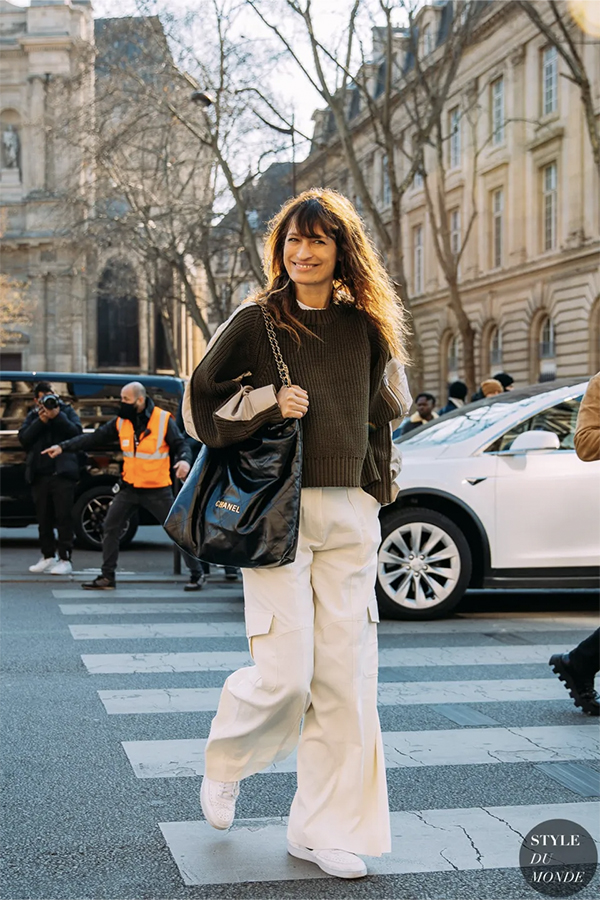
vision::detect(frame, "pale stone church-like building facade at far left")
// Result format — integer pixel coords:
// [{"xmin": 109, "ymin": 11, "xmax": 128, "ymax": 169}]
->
[{"xmin": 0, "ymin": 0, "xmax": 203, "ymax": 375}]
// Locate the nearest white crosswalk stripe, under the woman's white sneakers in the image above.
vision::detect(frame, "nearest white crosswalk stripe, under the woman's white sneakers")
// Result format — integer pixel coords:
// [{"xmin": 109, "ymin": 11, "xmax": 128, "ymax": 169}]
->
[{"xmin": 160, "ymin": 803, "xmax": 598, "ymax": 884}]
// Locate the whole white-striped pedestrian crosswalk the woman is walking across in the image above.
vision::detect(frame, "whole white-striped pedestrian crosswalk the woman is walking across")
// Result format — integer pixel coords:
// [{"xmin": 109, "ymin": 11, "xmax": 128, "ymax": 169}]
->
[{"xmin": 53, "ymin": 585, "xmax": 600, "ymax": 896}]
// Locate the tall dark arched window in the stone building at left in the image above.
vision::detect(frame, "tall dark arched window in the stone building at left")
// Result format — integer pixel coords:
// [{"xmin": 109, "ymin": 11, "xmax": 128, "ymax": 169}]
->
[{"xmin": 97, "ymin": 260, "xmax": 140, "ymax": 369}]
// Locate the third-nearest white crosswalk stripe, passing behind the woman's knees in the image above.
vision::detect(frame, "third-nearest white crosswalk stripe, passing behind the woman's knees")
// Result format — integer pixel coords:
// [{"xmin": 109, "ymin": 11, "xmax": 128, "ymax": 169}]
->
[{"xmin": 98, "ymin": 674, "xmax": 565, "ymax": 715}]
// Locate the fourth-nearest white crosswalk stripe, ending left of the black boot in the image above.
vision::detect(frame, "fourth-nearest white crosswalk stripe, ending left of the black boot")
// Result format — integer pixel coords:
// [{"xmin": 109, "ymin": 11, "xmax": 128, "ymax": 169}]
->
[{"xmin": 81, "ymin": 644, "xmax": 556, "ymax": 675}]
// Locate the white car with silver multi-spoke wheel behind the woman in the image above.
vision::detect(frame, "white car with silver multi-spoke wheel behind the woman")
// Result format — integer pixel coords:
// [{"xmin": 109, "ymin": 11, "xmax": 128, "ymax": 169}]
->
[{"xmin": 377, "ymin": 381, "xmax": 600, "ymax": 619}]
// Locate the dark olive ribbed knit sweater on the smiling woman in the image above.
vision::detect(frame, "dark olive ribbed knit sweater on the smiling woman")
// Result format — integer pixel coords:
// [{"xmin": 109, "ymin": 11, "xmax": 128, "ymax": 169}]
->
[{"xmin": 191, "ymin": 303, "xmax": 399, "ymax": 503}]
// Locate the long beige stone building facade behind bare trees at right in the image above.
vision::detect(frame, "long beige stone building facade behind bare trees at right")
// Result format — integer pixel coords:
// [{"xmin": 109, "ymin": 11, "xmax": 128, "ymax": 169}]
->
[{"xmin": 298, "ymin": 2, "xmax": 600, "ymax": 399}]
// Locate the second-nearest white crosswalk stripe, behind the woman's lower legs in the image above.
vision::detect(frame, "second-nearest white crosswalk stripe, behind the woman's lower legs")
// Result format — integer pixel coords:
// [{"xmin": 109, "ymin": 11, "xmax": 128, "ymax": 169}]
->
[{"xmin": 123, "ymin": 725, "xmax": 600, "ymax": 778}]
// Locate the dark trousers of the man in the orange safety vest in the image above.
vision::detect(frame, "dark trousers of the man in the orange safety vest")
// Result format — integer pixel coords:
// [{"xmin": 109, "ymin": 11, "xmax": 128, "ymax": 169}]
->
[{"xmin": 102, "ymin": 484, "xmax": 202, "ymax": 579}]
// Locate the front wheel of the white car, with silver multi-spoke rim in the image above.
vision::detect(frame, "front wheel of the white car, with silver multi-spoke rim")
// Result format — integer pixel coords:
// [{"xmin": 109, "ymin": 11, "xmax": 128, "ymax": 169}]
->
[{"xmin": 376, "ymin": 506, "xmax": 471, "ymax": 619}]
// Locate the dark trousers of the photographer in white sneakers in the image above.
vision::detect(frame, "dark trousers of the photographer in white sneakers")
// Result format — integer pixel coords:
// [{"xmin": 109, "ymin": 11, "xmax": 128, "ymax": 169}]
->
[{"xmin": 31, "ymin": 475, "xmax": 75, "ymax": 559}]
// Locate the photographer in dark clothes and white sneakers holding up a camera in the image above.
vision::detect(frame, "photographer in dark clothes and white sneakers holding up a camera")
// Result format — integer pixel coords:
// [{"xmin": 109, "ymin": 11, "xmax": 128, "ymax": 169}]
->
[{"xmin": 19, "ymin": 381, "xmax": 83, "ymax": 575}]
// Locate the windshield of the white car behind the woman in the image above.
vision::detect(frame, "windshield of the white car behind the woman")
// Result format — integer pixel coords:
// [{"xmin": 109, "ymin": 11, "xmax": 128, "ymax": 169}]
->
[{"xmin": 397, "ymin": 395, "xmax": 556, "ymax": 449}]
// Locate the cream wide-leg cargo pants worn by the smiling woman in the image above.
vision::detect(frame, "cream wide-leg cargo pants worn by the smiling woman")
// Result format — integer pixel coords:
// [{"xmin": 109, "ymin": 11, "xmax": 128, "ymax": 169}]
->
[{"xmin": 206, "ymin": 488, "xmax": 391, "ymax": 856}]
